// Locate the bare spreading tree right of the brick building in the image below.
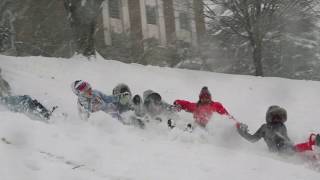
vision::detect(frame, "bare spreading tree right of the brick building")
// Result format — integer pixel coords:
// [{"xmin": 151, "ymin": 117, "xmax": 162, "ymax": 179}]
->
[{"xmin": 204, "ymin": 0, "xmax": 316, "ymax": 76}]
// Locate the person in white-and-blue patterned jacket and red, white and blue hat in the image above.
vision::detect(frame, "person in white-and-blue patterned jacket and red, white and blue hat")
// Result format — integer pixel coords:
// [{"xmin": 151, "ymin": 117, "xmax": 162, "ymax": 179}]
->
[{"xmin": 71, "ymin": 80, "xmax": 121, "ymax": 120}]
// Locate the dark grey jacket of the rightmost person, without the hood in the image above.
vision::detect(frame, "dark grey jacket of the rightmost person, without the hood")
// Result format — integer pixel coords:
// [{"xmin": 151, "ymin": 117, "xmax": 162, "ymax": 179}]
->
[{"xmin": 238, "ymin": 122, "xmax": 293, "ymax": 152}]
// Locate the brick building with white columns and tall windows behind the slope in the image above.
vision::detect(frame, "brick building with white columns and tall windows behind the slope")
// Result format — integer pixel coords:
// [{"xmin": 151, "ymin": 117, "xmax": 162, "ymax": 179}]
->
[{"xmin": 98, "ymin": 0, "xmax": 205, "ymax": 54}]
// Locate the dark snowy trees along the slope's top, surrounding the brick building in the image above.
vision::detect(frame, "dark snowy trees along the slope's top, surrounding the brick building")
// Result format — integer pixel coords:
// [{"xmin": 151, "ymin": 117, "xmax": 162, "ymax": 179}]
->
[{"xmin": 0, "ymin": 0, "xmax": 320, "ymax": 80}]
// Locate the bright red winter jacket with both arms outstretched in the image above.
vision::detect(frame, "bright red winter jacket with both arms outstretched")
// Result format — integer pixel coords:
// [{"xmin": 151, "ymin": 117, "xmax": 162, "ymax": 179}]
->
[{"xmin": 174, "ymin": 100, "xmax": 229, "ymax": 126}]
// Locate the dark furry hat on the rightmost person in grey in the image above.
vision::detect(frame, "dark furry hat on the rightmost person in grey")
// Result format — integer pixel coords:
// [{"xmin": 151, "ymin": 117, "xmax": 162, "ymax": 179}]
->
[{"xmin": 266, "ymin": 105, "xmax": 287, "ymax": 123}]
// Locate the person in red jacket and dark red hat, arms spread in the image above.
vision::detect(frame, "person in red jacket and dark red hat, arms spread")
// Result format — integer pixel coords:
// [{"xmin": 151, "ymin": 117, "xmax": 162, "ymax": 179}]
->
[{"xmin": 173, "ymin": 86, "xmax": 229, "ymax": 127}]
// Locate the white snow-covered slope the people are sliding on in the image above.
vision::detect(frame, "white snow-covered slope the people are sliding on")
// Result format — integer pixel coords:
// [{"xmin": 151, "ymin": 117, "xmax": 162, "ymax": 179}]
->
[{"xmin": 0, "ymin": 56, "xmax": 320, "ymax": 180}]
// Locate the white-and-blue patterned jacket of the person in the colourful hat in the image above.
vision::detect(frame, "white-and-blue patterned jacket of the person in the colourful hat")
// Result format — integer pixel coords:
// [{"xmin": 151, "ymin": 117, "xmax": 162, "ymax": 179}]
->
[{"xmin": 78, "ymin": 90, "xmax": 120, "ymax": 120}]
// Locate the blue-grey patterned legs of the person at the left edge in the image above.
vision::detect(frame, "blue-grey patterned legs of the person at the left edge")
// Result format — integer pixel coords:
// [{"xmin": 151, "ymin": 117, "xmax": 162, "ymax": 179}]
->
[{"xmin": 0, "ymin": 95, "xmax": 57, "ymax": 120}]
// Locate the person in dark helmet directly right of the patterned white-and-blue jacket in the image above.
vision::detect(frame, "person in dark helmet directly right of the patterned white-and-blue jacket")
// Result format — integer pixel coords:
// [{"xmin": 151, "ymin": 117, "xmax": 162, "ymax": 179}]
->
[{"xmin": 112, "ymin": 83, "xmax": 133, "ymax": 114}]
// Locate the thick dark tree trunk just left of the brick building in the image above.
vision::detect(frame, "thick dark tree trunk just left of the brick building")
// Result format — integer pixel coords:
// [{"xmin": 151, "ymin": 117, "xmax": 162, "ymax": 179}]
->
[{"xmin": 64, "ymin": 0, "xmax": 104, "ymax": 57}]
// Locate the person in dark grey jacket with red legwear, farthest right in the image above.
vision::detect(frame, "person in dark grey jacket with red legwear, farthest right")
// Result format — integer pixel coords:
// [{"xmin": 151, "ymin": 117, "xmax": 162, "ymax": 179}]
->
[{"xmin": 236, "ymin": 106, "xmax": 320, "ymax": 153}]
